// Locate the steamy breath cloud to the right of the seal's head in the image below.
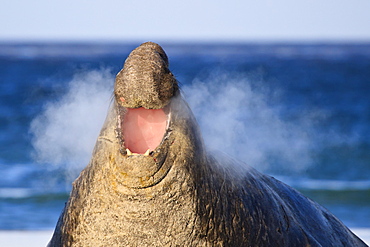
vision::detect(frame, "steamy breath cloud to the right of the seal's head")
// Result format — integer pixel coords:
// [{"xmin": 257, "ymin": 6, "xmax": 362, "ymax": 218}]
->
[{"xmin": 183, "ymin": 72, "xmax": 320, "ymax": 173}]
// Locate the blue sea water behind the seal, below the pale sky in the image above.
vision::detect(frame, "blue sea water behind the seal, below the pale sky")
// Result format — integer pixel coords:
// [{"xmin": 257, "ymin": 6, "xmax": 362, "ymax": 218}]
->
[{"xmin": 0, "ymin": 43, "xmax": 370, "ymax": 230}]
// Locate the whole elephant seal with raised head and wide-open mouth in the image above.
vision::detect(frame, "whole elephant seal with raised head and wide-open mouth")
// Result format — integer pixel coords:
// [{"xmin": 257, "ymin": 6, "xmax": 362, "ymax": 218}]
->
[{"xmin": 48, "ymin": 42, "xmax": 366, "ymax": 247}]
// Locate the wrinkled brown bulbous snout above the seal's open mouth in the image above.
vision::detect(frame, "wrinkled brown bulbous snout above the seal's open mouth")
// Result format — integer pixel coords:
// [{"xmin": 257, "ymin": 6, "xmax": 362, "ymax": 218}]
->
[{"xmin": 114, "ymin": 42, "xmax": 178, "ymax": 109}]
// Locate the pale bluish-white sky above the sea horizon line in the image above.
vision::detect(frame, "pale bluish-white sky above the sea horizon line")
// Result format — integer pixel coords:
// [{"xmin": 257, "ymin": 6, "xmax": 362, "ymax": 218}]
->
[{"xmin": 0, "ymin": 0, "xmax": 370, "ymax": 41}]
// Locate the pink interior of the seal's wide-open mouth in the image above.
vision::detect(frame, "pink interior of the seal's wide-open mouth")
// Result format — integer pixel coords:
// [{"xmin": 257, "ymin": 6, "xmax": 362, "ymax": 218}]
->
[{"xmin": 122, "ymin": 107, "xmax": 167, "ymax": 154}]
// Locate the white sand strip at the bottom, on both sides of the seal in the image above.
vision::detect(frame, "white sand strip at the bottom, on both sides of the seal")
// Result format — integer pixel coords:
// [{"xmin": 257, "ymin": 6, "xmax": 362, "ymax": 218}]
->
[{"xmin": 0, "ymin": 228, "xmax": 370, "ymax": 247}]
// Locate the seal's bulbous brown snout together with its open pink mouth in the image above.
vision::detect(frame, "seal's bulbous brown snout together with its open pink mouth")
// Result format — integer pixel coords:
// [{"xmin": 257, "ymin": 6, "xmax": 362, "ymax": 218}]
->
[{"xmin": 114, "ymin": 42, "xmax": 178, "ymax": 156}]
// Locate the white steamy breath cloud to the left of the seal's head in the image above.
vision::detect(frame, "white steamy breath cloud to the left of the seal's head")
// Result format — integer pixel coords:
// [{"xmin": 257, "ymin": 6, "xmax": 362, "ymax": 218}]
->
[{"xmin": 30, "ymin": 70, "xmax": 114, "ymax": 176}]
